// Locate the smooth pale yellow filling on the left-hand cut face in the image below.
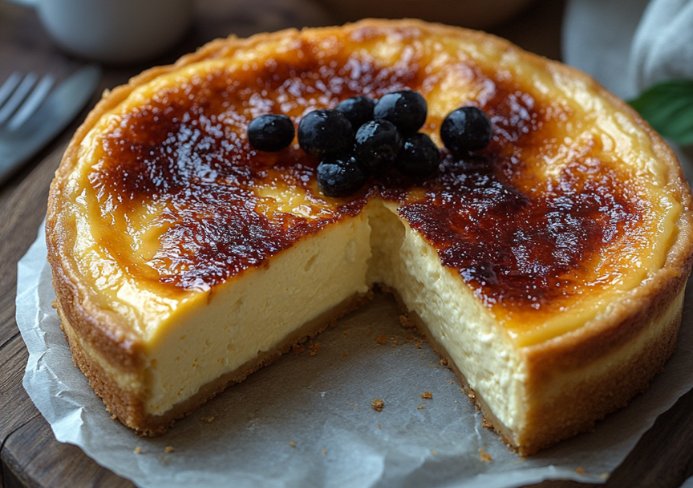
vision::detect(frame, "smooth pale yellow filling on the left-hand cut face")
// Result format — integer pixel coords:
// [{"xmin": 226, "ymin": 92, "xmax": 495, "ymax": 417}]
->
[{"xmin": 145, "ymin": 214, "xmax": 370, "ymax": 415}]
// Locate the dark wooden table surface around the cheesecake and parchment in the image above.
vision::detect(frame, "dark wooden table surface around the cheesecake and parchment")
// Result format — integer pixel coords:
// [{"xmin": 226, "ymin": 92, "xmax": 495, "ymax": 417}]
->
[{"xmin": 0, "ymin": 0, "xmax": 693, "ymax": 488}]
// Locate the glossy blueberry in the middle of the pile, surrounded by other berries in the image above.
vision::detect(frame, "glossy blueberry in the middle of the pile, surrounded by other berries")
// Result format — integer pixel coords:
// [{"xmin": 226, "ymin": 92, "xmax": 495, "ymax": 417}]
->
[{"xmin": 354, "ymin": 120, "xmax": 402, "ymax": 174}]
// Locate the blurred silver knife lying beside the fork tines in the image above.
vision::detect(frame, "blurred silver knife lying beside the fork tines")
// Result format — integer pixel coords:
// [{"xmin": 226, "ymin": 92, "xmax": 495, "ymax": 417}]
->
[{"xmin": 0, "ymin": 64, "xmax": 101, "ymax": 185}]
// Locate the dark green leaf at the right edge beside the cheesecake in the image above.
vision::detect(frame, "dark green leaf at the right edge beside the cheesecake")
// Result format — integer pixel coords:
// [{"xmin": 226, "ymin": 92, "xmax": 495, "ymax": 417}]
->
[{"xmin": 628, "ymin": 80, "xmax": 693, "ymax": 146}]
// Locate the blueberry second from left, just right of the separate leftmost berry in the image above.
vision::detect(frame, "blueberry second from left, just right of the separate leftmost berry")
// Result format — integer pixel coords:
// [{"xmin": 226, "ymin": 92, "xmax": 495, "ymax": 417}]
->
[{"xmin": 298, "ymin": 110, "xmax": 354, "ymax": 157}]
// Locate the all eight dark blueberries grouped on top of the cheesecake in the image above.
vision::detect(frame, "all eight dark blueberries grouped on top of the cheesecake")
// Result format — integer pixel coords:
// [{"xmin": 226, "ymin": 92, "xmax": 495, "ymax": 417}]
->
[{"xmin": 248, "ymin": 90, "xmax": 493, "ymax": 197}]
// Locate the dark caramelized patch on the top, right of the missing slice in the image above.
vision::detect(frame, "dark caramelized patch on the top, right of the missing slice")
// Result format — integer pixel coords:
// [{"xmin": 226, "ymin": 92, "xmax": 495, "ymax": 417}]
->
[{"xmin": 392, "ymin": 154, "xmax": 642, "ymax": 309}]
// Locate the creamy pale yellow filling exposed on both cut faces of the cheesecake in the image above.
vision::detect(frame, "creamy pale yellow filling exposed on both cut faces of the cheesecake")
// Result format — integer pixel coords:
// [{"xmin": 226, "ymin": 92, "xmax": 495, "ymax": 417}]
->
[{"xmin": 108, "ymin": 200, "xmax": 525, "ymax": 429}]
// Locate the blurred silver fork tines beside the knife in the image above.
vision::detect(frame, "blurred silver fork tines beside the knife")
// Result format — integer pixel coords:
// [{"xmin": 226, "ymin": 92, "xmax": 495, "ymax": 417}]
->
[{"xmin": 0, "ymin": 73, "xmax": 54, "ymax": 131}]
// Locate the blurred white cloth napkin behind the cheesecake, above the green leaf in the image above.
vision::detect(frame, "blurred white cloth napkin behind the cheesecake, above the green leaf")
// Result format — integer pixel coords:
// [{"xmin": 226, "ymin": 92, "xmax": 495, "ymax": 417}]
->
[{"xmin": 563, "ymin": 0, "xmax": 693, "ymax": 99}]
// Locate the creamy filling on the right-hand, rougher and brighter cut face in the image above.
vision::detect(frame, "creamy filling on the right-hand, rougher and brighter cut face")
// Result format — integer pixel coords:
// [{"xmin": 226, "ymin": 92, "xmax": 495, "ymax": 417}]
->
[{"xmin": 368, "ymin": 204, "xmax": 526, "ymax": 430}]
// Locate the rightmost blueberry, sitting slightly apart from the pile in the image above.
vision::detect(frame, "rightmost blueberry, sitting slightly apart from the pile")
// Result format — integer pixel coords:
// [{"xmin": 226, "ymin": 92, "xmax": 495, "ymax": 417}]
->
[{"xmin": 440, "ymin": 107, "xmax": 493, "ymax": 153}]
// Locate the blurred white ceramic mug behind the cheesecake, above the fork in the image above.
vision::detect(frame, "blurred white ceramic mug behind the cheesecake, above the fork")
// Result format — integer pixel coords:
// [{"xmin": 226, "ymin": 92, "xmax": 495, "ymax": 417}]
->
[{"xmin": 12, "ymin": 0, "xmax": 193, "ymax": 63}]
